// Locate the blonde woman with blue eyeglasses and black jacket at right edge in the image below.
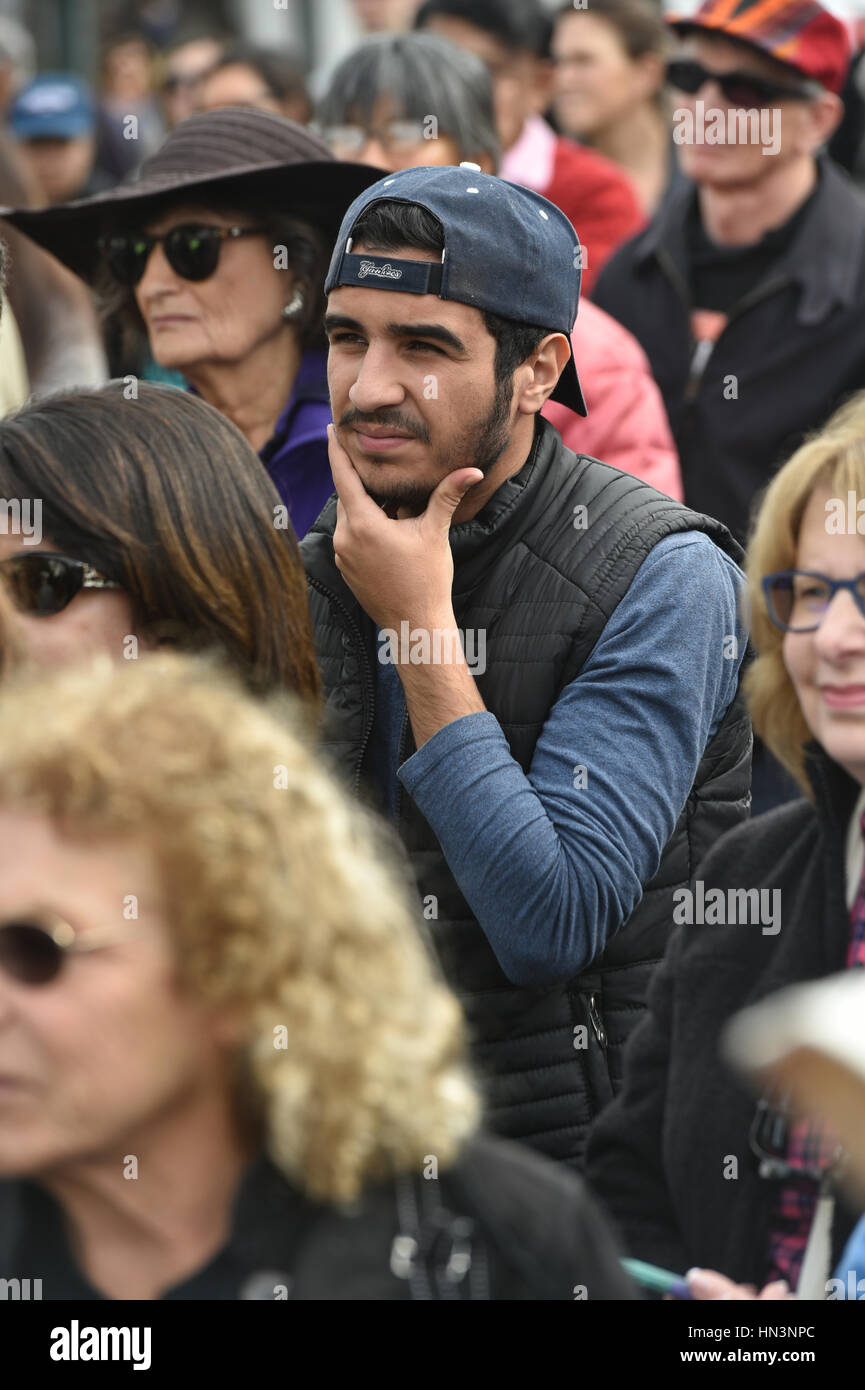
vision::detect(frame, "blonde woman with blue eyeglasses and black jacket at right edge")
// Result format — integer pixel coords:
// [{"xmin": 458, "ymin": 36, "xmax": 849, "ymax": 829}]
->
[{"xmin": 587, "ymin": 395, "xmax": 865, "ymax": 1298}]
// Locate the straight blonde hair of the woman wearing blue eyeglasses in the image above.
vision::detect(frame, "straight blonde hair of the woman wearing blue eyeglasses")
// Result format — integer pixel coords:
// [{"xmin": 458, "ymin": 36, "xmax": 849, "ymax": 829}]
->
[{"xmin": 744, "ymin": 392, "xmax": 865, "ymax": 798}]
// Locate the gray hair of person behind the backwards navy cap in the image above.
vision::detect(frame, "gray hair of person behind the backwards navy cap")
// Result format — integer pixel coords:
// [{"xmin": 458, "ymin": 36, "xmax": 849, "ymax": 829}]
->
[{"xmin": 317, "ymin": 33, "xmax": 501, "ymax": 167}]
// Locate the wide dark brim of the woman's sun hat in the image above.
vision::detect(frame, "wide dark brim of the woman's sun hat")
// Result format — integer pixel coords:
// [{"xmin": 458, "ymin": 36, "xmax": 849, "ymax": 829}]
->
[{"xmin": 0, "ymin": 160, "xmax": 385, "ymax": 282}]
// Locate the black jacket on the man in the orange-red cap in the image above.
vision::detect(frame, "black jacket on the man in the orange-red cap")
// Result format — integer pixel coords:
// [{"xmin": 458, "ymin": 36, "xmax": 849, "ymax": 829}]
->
[{"xmin": 592, "ymin": 160, "xmax": 865, "ymax": 541}]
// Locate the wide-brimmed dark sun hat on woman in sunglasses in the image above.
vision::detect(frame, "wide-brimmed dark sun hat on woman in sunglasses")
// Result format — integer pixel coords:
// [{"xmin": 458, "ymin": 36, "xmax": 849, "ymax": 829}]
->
[{"xmin": 0, "ymin": 107, "xmax": 384, "ymax": 281}]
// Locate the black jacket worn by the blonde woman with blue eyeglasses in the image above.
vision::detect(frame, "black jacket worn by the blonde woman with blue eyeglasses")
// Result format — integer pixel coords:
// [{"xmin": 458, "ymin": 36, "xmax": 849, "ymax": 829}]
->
[{"xmin": 587, "ymin": 745, "xmax": 859, "ymax": 1286}]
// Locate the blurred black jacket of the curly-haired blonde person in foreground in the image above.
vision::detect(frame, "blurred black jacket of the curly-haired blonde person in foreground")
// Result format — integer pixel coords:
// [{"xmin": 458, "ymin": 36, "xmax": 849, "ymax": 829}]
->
[{"xmin": 0, "ymin": 1136, "xmax": 638, "ymax": 1301}]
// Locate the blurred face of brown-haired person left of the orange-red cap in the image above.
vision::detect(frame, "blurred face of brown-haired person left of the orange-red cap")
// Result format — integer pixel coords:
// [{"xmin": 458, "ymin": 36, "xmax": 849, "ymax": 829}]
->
[{"xmin": 552, "ymin": 11, "xmax": 663, "ymax": 139}]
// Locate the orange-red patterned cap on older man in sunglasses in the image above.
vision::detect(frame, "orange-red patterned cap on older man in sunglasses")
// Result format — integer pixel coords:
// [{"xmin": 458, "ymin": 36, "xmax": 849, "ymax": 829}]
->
[{"xmin": 670, "ymin": 0, "xmax": 851, "ymax": 93}]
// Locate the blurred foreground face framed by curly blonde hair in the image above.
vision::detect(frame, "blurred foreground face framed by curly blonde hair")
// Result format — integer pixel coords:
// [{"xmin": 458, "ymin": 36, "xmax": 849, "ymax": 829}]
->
[{"xmin": 0, "ymin": 808, "xmax": 237, "ymax": 1177}]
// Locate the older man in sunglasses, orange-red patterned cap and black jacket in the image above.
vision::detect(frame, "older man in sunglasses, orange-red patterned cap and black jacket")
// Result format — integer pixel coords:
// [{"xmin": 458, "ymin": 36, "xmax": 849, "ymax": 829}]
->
[{"xmin": 594, "ymin": 0, "xmax": 865, "ymax": 810}]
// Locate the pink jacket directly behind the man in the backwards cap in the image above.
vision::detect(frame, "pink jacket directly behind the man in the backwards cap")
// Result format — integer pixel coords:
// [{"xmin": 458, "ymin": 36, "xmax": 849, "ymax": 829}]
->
[{"xmin": 542, "ymin": 299, "xmax": 683, "ymax": 502}]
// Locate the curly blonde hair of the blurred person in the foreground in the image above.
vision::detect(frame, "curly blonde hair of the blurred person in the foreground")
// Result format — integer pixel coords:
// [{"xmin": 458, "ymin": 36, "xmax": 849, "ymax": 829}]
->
[{"xmin": 0, "ymin": 653, "xmax": 480, "ymax": 1201}]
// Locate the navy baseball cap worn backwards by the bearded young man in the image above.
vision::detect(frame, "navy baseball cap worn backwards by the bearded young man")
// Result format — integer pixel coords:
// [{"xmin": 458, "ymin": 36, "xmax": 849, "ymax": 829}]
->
[{"xmin": 324, "ymin": 164, "xmax": 587, "ymax": 416}]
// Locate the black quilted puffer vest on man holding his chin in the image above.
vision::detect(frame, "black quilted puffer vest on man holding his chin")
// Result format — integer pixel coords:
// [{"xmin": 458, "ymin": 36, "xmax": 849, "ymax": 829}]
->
[{"xmin": 302, "ymin": 420, "xmax": 751, "ymax": 1166}]
